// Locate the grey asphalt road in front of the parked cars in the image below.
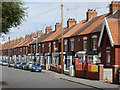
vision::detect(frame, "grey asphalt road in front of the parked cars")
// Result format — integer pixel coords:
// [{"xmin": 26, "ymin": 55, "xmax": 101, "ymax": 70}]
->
[{"xmin": 0, "ymin": 66, "xmax": 99, "ymax": 90}]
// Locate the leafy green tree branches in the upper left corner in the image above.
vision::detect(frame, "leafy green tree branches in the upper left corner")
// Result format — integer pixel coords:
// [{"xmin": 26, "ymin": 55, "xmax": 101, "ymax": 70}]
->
[{"xmin": 0, "ymin": 2, "xmax": 27, "ymax": 34}]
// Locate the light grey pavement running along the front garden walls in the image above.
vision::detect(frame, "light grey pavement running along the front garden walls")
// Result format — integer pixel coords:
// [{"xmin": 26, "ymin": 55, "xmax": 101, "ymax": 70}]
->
[{"xmin": 43, "ymin": 70, "xmax": 120, "ymax": 90}]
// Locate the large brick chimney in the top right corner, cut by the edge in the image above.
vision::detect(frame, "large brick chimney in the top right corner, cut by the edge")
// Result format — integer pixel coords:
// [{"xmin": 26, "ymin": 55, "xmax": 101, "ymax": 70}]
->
[{"xmin": 109, "ymin": 1, "xmax": 120, "ymax": 14}]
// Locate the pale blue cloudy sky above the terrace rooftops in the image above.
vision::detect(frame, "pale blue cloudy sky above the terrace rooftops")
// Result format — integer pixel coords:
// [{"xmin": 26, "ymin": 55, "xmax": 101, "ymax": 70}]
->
[{"xmin": 0, "ymin": 0, "xmax": 111, "ymax": 43}]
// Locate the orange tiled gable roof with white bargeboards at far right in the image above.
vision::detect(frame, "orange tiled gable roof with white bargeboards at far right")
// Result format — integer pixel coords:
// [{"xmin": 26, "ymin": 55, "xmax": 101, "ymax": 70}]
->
[{"xmin": 98, "ymin": 10, "xmax": 120, "ymax": 46}]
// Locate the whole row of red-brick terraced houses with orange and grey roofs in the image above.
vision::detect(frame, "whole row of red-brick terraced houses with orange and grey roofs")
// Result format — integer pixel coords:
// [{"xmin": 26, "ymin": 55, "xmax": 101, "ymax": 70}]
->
[{"xmin": 0, "ymin": 1, "xmax": 120, "ymax": 82}]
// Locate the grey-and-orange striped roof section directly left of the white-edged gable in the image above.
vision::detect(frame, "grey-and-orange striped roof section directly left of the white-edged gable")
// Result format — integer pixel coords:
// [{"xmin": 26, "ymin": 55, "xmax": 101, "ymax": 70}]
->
[{"xmin": 71, "ymin": 14, "xmax": 108, "ymax": 36}]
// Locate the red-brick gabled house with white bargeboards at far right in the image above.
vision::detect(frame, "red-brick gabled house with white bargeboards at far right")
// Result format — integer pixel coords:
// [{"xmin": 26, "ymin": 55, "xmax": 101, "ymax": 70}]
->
[{"xmin": 98, "ymin": 10, "xmax": 120, "ymax": 68}]
